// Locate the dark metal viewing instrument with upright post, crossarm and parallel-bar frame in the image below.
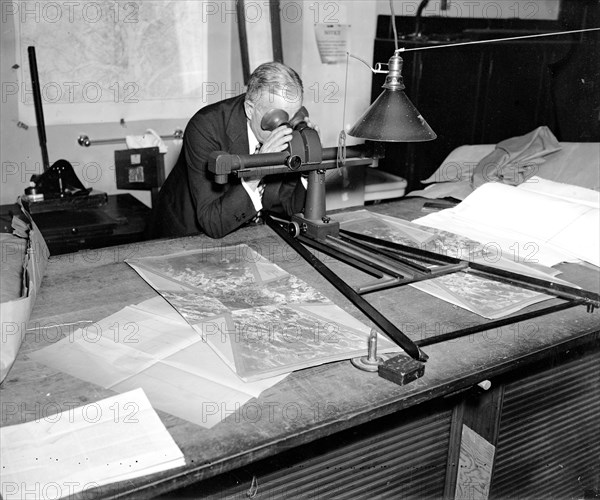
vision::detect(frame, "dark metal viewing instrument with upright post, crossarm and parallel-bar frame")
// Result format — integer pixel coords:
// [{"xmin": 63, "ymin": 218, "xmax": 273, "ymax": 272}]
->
[{"xmin": 208, "ymin": 127, "xmax": 600, "ymax": 368}]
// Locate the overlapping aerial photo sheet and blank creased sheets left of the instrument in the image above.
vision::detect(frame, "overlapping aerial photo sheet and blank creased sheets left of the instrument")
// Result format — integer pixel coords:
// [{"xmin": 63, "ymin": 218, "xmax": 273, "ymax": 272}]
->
[{"xmin": 30, "ymin": 245, "xmax": 399, "ymax": 428}]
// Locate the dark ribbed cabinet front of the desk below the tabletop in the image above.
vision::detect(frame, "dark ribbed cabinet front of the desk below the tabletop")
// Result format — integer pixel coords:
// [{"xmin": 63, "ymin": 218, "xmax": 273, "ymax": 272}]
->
[{"xmin": 158, "ymin": 336, "xmax": 600, "ymax": 500}]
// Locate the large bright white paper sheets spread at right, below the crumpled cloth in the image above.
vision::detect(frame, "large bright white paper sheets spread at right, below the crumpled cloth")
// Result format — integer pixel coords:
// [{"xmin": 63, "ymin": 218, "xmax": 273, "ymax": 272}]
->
[{"xmin": 413, "ymin": 177, "xmax": 600, "ymax": 266}]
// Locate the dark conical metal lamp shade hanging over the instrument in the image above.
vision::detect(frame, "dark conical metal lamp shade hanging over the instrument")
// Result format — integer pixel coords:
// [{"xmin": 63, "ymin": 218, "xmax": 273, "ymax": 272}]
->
[{"xmin": 348, "ymin": 88, "xmax": 437, "ymax": 142}]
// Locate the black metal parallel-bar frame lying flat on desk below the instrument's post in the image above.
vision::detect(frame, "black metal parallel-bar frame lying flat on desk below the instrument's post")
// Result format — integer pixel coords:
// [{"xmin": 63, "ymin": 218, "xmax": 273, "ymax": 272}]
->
[{"xmin": 264, "ymin": 214, "xmax": 600, "ymax": 361}]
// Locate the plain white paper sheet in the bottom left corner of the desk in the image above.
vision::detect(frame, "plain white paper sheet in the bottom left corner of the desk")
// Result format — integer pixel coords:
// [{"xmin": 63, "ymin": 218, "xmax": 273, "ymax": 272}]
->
[{"xmin": 0, "ymin": 389, "xmax": 185, "ymax": 500}]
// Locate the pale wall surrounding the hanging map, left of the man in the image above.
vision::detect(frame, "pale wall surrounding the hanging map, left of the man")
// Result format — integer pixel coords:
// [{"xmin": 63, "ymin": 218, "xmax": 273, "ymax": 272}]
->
[{"xmin": 0, "ymin": 0, "xmax": 242, "ymax": 205}]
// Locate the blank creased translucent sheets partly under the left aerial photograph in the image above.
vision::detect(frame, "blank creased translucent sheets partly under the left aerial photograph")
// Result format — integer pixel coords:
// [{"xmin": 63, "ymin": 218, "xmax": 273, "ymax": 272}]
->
[{"xmin": 30, "ymin": 297, "xmax": 285, "ymax": 428}]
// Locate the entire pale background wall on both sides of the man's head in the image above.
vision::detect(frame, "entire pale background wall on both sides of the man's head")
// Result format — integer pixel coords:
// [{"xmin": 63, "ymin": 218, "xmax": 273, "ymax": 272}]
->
[{"xmin": 0, "ymin": 0, "xmax": 559, "ymax": 204}]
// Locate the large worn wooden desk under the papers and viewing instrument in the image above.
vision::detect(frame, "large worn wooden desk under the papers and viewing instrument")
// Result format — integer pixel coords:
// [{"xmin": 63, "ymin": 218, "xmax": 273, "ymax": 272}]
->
[{"xmin": 1, "ymin": 199, "xmax": 600, "ymax": 499}]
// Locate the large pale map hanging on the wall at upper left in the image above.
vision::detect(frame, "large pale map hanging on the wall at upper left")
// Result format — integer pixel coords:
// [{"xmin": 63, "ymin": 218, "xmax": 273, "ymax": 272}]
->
[{"xmin": 13, "ymin": 0, "xmax": 207, "ymax": 125}]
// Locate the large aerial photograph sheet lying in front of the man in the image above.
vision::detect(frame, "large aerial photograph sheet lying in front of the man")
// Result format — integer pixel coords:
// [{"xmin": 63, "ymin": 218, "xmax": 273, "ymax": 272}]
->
[{"xmin": 127, "ymin": 245, "xmax": 400, "ymax": 381}]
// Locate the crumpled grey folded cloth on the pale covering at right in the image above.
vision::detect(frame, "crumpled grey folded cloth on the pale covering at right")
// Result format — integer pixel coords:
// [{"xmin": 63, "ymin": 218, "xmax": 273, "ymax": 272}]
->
[{"xmin": 471, "ymin": 126, "xmax": 561, "ymax": 188}]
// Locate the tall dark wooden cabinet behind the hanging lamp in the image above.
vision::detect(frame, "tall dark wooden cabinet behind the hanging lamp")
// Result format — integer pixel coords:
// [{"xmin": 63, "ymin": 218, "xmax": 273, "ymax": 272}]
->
[{"xmin": 372, "ymin": 12, "xmax": 600, "ymax": 191}]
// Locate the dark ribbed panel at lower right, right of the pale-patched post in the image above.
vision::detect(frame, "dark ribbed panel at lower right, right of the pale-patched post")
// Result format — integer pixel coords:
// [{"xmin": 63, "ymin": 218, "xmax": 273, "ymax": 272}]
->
[{"xmin": 490, "ymin": 353, "xmax": 600, "ymax": 499}]
